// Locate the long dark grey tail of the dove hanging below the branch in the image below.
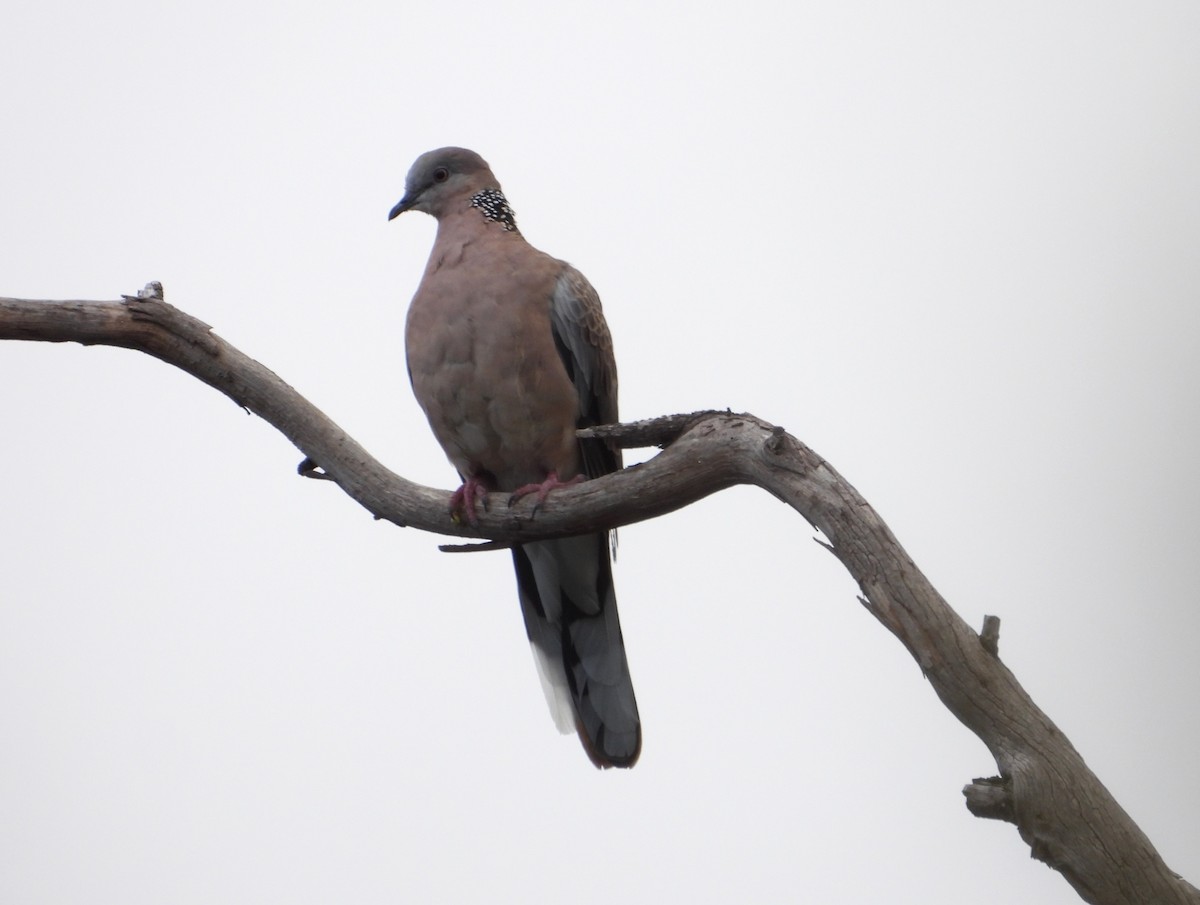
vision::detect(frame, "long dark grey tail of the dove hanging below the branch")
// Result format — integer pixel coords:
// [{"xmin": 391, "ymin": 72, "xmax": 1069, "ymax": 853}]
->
[{"xmin": 512, "ymin": 533, "xmax": 642, "ymax": 767}]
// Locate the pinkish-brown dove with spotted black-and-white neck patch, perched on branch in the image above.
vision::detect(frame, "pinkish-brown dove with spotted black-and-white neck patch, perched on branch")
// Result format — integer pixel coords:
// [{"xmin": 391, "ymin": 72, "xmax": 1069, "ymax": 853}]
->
[{"xmin": 388, "ymin": 148, "xmax": 642, "ymax": 768}]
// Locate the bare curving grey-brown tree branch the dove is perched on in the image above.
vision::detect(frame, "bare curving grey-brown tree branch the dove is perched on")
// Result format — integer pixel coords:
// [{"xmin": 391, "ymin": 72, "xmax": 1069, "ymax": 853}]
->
[{"xmin": 0, "ymin": 284, "xmax": 1200, "ymax": 905}]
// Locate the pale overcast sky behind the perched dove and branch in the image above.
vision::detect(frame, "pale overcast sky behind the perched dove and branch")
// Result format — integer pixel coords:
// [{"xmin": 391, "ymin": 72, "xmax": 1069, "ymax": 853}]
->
[{"xmin": 0, "ymin": 0, "xmax": 1200, "ymax": 905}]
